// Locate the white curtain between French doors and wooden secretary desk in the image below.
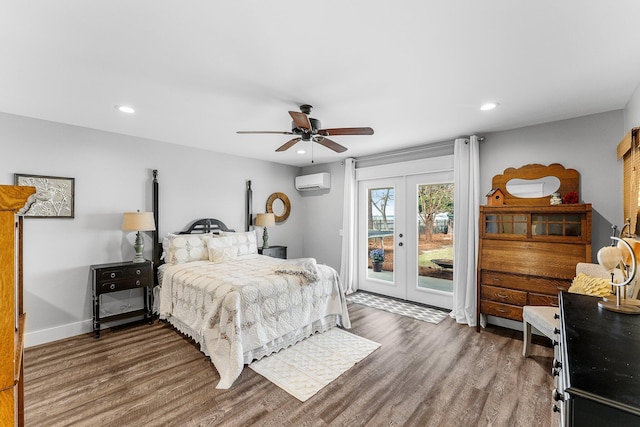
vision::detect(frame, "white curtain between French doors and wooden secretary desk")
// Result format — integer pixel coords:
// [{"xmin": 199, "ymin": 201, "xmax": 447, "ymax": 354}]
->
[{"xmin": 450, "ymin": 135, "xmax": 480, "ymax": 326}]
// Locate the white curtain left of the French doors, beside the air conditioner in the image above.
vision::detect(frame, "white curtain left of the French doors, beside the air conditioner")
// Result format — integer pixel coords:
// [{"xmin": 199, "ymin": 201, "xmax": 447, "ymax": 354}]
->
[{"xmin": 340, "ymin": 158, "xmax": 358, "ymax": 294}]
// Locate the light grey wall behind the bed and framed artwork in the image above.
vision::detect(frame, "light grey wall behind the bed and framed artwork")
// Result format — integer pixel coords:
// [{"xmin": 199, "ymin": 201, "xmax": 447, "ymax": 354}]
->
[{"xmin": 0, "ymin": 113, "xmax": 304, "ymax": 345}]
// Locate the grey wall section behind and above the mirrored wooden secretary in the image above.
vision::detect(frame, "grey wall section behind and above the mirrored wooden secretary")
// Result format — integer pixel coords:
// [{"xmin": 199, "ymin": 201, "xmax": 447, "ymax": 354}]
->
[{"xmin": 480, "ymin": 110, "xmax": 625, "ymax": 259}]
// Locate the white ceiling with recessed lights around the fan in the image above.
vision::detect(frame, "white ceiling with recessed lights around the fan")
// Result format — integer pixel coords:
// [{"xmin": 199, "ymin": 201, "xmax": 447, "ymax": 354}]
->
[{"xmin": 0, "ymin": 0, "xmax": 640, "ymax": 166}]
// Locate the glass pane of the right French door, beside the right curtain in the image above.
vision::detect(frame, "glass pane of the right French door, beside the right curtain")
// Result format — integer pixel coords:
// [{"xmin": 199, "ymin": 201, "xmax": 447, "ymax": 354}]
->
[{"xmin": 417, "ymin": 184, "xmax": 454, "ymax": 292}]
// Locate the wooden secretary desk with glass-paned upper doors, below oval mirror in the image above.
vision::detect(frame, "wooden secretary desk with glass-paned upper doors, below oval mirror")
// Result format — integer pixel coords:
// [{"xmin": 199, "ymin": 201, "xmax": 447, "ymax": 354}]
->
[{"xmin": 476, "ymin": 204, "xmax": 591, "ymax": 330}]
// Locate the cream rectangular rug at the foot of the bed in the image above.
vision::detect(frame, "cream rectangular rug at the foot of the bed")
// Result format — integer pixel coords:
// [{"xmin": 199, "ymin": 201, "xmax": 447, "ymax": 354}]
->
[{"xmin": 249, "ymin": 328, "xmax": 380, "ymax": 402}]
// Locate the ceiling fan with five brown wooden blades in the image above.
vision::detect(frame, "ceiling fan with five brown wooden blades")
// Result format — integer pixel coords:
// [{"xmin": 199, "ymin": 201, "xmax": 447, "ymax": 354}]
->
[{"xmin": 237, "ymin": 104, "xmax": 373, "ymax": 153}]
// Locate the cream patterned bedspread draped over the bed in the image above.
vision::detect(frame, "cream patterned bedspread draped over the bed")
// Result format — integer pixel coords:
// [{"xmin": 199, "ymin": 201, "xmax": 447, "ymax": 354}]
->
[{"xmin": 158, "ymin": 254, "xmax": 351, "ymax": 388}]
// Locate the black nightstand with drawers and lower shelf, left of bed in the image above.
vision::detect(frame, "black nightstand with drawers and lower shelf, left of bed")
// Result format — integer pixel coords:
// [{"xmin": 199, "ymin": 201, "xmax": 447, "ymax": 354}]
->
[{"xmin": 91, "ymin": 261, "xmax": 153, "ymax": 338}]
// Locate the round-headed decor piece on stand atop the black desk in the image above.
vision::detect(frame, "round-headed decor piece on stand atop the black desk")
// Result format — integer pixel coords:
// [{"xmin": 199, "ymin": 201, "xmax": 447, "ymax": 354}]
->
[{"xmin": 598, "ymin": 222, "xmax": 640, "ymax": 314}]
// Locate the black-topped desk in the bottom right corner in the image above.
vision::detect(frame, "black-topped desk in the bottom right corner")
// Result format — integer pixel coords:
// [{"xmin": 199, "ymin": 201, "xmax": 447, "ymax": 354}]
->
[{"xmin": 553, "ymin": 292, "xmax": 640, "ymax": 427}]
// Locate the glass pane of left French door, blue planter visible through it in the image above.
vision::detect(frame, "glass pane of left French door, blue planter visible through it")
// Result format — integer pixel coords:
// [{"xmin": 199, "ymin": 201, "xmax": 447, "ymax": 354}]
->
[{"xmin": 367, "ymin": 187, "xmax": 395, "ymax": 282}]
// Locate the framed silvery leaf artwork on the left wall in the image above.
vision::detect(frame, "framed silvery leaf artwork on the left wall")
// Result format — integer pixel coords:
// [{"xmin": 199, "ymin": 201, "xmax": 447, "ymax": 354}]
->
[{"xmin": 14, "ymin": 173, "xmax": 75, "ymax": 218}]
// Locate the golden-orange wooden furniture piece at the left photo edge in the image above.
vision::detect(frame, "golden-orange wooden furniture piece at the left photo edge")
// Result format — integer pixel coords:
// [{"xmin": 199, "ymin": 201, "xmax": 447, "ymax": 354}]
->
[{"xmin": 0, "ymin": 185, "xmax": 36, "ymax": 426}]
